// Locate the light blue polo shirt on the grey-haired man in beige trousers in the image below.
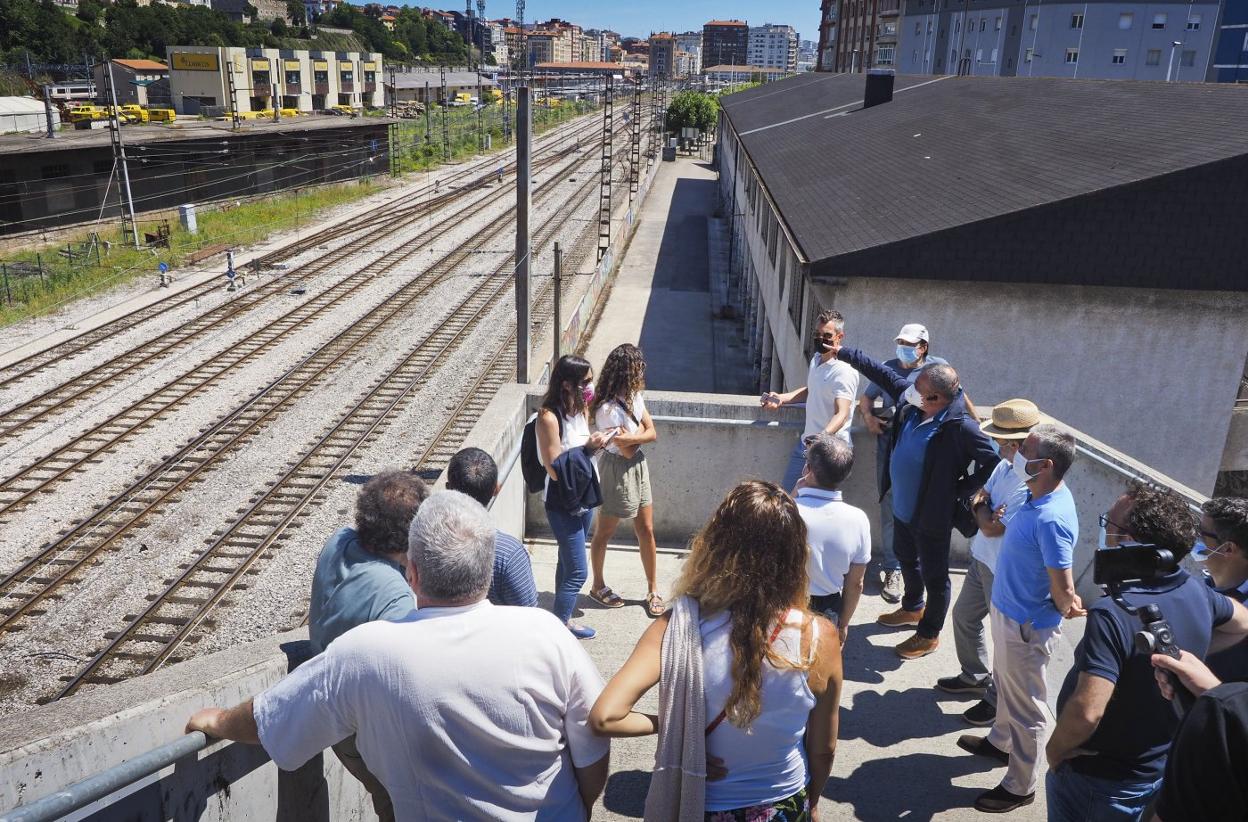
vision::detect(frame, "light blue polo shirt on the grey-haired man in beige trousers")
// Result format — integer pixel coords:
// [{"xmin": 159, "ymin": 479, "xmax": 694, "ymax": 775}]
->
[{"xmin": 992, "ymin": 483, "xmax": 1080, "ymax": 627}]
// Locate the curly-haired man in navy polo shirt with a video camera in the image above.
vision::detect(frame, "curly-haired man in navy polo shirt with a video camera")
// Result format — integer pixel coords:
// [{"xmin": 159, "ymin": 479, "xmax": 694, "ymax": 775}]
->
[{"xmin": 1046, "ymin": 483, "xmax": 1248, "ymax": 822}]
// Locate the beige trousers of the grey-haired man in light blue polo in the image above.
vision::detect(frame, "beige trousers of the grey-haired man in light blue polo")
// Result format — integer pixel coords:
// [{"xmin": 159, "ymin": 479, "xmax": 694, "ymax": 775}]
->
[{"xmin": 988, "ymin": 606, "xmax": 1062, "ymax": 796}]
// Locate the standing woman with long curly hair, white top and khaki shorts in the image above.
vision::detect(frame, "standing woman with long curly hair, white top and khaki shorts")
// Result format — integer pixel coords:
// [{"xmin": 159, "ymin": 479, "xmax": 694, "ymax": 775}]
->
[{"xmin": 589, "ymin": 343, "xmax": 664, "ymax": 616}]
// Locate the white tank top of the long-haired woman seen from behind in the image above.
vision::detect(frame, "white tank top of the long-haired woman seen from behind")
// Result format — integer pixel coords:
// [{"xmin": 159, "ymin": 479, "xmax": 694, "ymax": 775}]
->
[{"xmin": 700, "ymin": 610, "xmax": 819, "ymax": 811}]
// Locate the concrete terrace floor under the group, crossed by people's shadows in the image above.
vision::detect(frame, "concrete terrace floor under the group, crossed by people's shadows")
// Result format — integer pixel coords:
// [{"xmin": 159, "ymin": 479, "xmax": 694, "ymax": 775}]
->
[{"xmin": 530, "ymin": 541, "xmax": 1053, "ymax": 822}]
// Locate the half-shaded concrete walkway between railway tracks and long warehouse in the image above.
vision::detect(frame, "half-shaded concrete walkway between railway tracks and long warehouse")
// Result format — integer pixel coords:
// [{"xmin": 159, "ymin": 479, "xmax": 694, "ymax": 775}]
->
[{"xmin": 587, "ymin": 157, "xmax": 753, "ymax": 393}]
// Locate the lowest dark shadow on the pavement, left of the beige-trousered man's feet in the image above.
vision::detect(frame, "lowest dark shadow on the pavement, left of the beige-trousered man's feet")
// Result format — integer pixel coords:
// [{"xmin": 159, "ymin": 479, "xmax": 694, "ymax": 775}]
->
[{"xmin": 824, "ymin": 750, "xmax": 992, "ymax": 822}]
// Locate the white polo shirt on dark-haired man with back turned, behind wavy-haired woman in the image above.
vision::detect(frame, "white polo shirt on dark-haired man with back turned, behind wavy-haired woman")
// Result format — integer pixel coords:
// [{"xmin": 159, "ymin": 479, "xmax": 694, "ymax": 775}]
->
[{"xmin": 797, "ymin": 488, "xmax": 871, "ymax": 596}]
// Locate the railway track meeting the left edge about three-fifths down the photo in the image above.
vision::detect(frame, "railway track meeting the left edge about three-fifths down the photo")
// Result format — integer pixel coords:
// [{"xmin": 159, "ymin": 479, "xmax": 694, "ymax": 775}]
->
[{"xmin": 0, "ymin": 137, "xmax": 614, "ymax": 521}]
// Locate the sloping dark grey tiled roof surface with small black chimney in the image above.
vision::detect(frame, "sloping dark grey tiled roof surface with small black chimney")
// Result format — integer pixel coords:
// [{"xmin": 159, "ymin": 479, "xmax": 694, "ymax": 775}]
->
[{"xmin": 721, "ymin": 72, "xmax": 1248, "ymax": 288}]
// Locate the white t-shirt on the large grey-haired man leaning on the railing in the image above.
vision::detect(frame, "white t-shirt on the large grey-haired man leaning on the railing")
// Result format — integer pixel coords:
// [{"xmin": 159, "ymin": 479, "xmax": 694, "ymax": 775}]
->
[{"xmin": 253, "ymin": 601, "xmax": 609, "ymax": 821}]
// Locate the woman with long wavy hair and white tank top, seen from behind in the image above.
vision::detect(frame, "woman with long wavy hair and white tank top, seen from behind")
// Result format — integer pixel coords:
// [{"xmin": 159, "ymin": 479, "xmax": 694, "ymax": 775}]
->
[{"xmin": 589, "ymin": 481, "xmax": 841, "ymax": 821}]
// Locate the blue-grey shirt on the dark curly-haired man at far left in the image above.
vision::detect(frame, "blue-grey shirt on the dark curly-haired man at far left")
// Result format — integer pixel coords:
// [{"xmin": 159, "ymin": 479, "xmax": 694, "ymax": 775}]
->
[{"xmin": 308, "ymin": 528, "xmax": 416, "ymax": 654}]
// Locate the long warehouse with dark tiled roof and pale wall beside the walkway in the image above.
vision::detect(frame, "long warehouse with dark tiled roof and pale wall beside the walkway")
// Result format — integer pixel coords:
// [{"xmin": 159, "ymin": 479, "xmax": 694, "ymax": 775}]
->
[{"xmin": 719, "ymin": 72, "xmax": 1248, "ymax": 496}]
